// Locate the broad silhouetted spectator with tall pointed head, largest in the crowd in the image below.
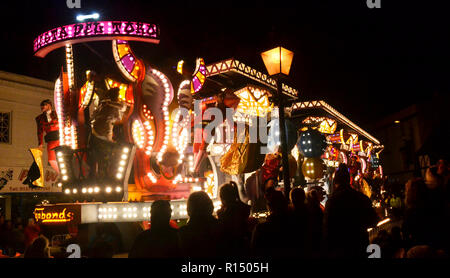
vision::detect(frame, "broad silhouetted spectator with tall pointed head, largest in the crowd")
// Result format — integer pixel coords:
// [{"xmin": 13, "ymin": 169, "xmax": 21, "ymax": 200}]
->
[{"xmin": 324, "ymin": 163, "xmax": 378, "ymax": 258}]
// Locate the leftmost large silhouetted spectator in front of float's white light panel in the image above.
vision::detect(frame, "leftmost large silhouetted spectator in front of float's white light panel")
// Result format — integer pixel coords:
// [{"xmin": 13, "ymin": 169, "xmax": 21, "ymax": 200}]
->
[{"xmin": 128, "ymin": 200, "xmax": 181, "ymax": 258}]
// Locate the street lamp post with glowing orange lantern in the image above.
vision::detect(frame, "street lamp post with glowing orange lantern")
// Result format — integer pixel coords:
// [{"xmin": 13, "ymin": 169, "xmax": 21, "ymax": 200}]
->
[{"xmin": 261, "ymin": 46, "xmax": 294, "ymax": 197}]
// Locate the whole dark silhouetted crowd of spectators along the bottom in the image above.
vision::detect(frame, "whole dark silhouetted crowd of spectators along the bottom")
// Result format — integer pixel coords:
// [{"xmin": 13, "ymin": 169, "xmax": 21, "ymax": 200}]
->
[{"xmin": 0, "ymin": 161, "xmax": 450, "ymax": 258}]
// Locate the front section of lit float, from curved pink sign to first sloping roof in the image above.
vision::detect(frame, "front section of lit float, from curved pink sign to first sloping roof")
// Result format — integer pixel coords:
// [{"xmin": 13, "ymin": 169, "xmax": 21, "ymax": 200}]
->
[{"xmin": 34, "ymin": 18, "xmax": 297, "ymax": 224}]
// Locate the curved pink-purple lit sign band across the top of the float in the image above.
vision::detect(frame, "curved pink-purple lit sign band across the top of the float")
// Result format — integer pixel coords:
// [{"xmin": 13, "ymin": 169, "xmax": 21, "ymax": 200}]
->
[{"xmin": 33, "ymin": 21, "xmax": 159, "ymax": 57}]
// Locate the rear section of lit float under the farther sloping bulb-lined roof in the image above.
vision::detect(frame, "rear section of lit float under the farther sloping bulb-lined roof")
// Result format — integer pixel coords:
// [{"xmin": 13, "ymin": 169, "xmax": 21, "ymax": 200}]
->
[{"xmin": 286, "ymin": 100, "xmax": 384, "ymax": 197}]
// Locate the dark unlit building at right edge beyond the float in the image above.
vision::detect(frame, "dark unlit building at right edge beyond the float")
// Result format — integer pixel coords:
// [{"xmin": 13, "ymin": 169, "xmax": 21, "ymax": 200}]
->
[{"xmin": 373, "ymin": 93, "xmax": 450, "ymax": 184}]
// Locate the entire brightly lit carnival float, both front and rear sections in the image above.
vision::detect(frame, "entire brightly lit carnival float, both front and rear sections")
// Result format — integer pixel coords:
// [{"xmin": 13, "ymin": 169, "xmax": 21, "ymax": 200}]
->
[{"xmin": 30, "ymin": 21, "xmax": 382, "ymax": 227}]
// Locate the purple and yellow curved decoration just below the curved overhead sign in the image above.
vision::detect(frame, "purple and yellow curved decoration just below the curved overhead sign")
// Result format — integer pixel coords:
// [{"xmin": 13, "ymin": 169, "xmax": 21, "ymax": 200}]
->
[{"xmin": 112, "ymin": 40, "xmax": 144, "ymax": 82}]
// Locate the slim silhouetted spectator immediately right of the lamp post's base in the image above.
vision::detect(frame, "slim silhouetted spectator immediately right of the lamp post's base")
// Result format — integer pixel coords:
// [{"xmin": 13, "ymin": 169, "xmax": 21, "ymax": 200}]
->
[{"xmin": 289, "ymin": 187, "xmax": 308, "ymax": 257}]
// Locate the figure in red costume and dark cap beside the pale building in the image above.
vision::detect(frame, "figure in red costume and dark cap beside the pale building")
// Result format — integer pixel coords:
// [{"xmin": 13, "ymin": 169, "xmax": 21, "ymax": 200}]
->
[{"xmin": 35, "ymin": 99, "xmax": 59, "ymax": 172}]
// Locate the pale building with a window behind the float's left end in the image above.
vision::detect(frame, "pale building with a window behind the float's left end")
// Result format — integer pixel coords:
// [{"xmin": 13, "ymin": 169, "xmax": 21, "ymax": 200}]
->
[{"xmin": 0, "ymin": 71, "xmax": 61, "ymax": 219}]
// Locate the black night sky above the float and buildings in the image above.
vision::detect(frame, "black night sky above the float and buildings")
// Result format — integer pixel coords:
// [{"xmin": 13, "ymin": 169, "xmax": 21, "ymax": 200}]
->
[{"xmin": 0, "ymin": 0, "xmax": 450, "ymax": 129}]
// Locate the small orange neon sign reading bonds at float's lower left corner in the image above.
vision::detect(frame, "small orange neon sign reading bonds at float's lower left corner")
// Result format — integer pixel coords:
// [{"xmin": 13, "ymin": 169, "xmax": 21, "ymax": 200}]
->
[{"xmin": 33, "ymin": 205, "xmax": 81, "ymax": 224}]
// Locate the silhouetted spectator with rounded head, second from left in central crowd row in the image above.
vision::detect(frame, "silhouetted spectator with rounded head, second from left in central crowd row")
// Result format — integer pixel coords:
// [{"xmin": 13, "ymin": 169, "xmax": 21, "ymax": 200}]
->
[{"xmin": 179, "ymin": 191, "xmax": 223, "ymax": 258}]
